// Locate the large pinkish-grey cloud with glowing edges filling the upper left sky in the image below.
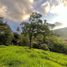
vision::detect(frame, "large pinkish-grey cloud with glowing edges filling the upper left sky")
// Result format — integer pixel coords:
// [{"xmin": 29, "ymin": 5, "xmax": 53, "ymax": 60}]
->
[{"xmin": 0, "ymin": 0, "xmax": 33, "ymax": 20}]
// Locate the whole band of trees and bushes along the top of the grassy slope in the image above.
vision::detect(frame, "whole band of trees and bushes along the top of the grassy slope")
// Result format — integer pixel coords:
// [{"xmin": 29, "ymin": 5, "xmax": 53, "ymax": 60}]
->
[{"xmin": 0, "ymin": 12, "xmax": 67, "ymax": 54}]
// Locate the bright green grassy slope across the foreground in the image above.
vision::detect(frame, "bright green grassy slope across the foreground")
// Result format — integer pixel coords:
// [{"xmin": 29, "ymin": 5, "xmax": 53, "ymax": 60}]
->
[{"xmin": 0, "ymin": 46, "xmax": 67, "ymax": 67}]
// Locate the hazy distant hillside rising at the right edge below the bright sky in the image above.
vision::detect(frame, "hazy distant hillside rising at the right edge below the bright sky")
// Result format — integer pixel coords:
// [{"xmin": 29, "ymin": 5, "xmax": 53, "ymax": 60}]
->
[{"xmin": 54, "ymin": 27, "xmax": 67, "ymax": 39}]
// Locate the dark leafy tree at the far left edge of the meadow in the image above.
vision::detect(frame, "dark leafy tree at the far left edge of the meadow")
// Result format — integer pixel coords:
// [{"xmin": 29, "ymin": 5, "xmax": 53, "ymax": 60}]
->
[{"xmin": 0, "ymin": 18, "xmax": 13, "ymax": 45}]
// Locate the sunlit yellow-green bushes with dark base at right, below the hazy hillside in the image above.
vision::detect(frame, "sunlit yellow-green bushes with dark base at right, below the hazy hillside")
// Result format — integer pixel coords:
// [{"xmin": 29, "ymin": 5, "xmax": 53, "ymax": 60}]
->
[{"xmin": 45, "ymin": 35, "xmax": 67, "ymax": 53}]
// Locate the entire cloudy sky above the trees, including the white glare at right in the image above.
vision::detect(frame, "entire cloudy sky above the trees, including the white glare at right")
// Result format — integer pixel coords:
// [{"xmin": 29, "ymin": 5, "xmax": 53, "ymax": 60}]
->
[{"xmin": 0, "ymin": 0, "xmax": 67, "ymax": 28}]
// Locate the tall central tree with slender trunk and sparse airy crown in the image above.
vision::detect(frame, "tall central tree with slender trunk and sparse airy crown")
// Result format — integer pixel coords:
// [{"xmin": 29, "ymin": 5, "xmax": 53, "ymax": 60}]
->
[{"xmin": 22, "ymin": 12, "xmax": 49, "ymax": 48}]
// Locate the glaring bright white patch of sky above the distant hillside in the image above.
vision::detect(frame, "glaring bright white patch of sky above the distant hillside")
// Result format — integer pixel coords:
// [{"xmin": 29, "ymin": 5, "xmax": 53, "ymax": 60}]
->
[{"xmin": 50, "ymin": 3, "xmax": 67, "ymax": 29}]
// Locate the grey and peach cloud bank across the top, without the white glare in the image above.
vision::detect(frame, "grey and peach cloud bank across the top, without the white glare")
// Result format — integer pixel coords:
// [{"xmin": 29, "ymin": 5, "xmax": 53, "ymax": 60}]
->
[{"xmin": 0, "ymin": 0, "xmax": 65, "ymax": 21}]
